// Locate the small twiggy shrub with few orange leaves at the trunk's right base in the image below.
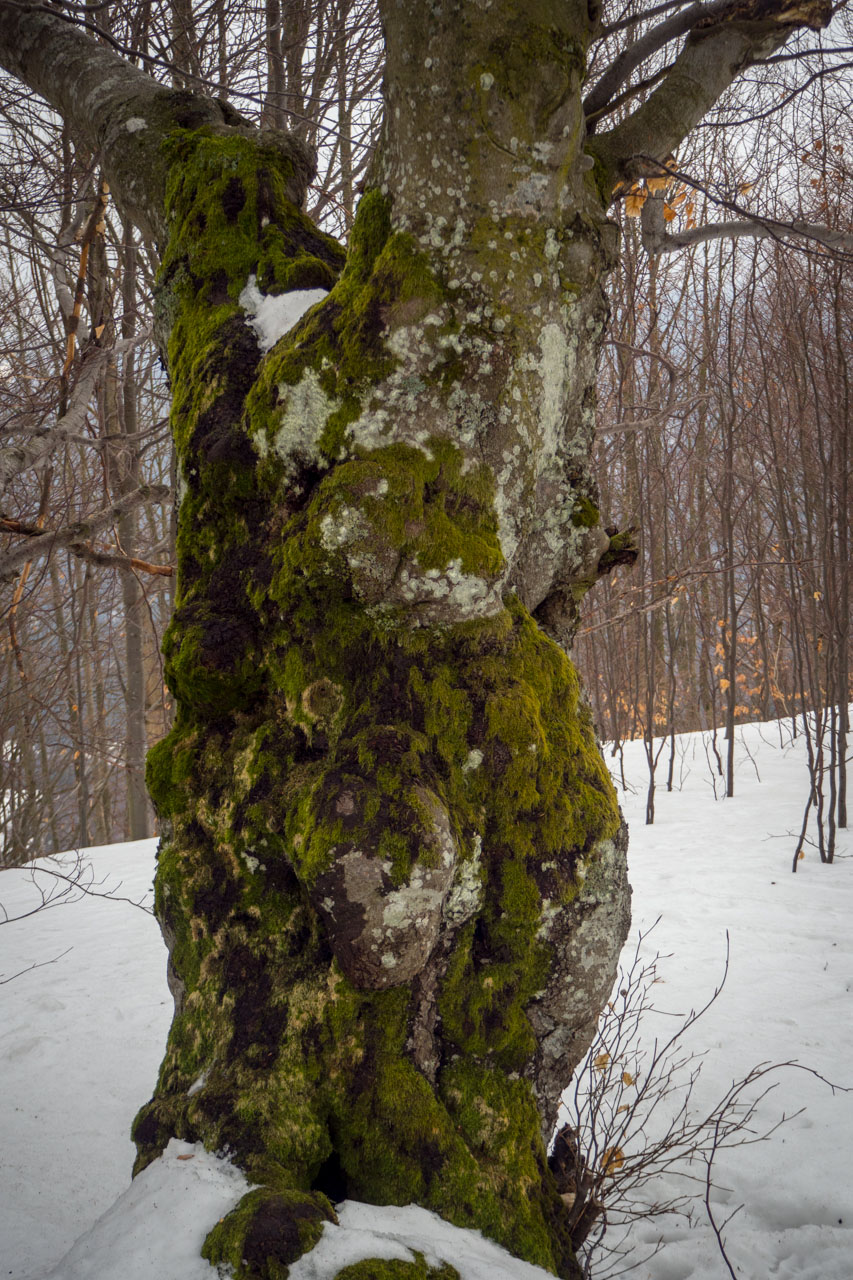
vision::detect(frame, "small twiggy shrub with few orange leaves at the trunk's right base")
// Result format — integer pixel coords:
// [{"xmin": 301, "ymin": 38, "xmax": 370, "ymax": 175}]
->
[{"xmin": 558, "ymin": 918, "xmax": 850, "ymax": 1276}]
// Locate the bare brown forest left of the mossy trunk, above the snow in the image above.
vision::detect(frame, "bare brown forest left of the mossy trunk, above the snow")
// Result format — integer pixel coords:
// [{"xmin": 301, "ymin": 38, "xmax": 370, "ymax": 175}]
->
[{"xmin": 0, "ymin": 0, "xmax": 382, "ymax": 865}]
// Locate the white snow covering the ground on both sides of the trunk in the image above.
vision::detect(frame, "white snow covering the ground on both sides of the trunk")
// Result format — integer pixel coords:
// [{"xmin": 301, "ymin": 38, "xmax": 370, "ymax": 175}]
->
[{"xmin": 0, "ymin": 726, "xmax": 853, "ymax": 1280}]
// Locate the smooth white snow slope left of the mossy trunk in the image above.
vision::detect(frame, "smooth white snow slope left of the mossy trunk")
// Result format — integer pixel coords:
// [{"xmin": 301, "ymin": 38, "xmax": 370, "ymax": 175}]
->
[{"xmin": 0, "ymin": 840, "xmax": 172, "ymax": 1280}]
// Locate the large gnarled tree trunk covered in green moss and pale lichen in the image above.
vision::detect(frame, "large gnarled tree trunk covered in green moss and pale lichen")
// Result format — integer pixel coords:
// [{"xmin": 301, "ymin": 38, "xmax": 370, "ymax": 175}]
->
[{"xmin": 0, "ymin": 0, "xmax": 824, "ymax": 1277}]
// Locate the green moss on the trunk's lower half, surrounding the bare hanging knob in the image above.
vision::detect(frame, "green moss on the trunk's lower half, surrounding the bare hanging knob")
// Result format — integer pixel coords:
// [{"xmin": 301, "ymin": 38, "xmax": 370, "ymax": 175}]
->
[{"xmin": 144, "ymin": 590, "xmax": 617, "ymax": 1275}]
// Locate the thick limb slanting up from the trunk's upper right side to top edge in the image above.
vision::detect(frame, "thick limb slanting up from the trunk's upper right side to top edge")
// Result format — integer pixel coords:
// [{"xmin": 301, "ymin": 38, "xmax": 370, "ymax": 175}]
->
[{"xmin": 589, "ymin": 0, "xmax": 833, "ymax": 186}]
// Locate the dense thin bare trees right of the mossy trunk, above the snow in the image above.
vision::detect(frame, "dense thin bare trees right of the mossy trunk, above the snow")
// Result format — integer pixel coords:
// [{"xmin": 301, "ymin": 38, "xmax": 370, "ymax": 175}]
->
[{"xmin": 575, "ymin": 45, "xmax": 853, "ymax": 860}]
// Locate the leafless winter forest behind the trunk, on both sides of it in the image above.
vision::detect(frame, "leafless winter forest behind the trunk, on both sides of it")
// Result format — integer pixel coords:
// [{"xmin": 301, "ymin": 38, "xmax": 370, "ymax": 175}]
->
[{"xmin": 0, "ymin": 0, "xmax": 853, "ymax": 865}]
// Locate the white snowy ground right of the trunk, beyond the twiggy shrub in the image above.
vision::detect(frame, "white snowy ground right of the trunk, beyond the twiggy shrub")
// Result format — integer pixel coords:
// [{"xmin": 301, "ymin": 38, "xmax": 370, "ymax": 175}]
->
[{"xmin": 611, "ymin": 724, "xmax": 853, "ymax": 1280}]
